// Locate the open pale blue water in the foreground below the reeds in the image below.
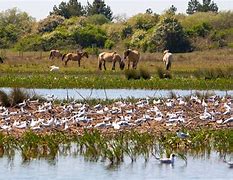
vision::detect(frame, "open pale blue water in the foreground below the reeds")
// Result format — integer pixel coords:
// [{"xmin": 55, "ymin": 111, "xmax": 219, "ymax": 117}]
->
[{"xmin": 0, "ymin": 153, "xmax": 233, "ymax": 180}]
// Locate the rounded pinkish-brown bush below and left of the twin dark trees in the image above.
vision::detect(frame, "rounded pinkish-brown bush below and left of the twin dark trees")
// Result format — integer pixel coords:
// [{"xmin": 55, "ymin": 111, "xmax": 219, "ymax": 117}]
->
[{"xmin": 37, "ymin": 15, "xmax": 65, "ymax": 33}]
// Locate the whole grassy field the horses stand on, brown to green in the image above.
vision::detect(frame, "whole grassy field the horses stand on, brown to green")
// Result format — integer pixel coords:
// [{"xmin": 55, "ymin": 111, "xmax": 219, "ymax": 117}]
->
[{"xmin": 0, "ymin": 49, "xmax": 233, "ymax": 90}]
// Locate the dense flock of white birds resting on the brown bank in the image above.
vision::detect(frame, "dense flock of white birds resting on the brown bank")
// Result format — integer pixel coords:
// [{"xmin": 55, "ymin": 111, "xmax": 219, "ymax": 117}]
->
[{"xmin": 0, "ymin": 95, "xmax": 233, "ymax": 133}]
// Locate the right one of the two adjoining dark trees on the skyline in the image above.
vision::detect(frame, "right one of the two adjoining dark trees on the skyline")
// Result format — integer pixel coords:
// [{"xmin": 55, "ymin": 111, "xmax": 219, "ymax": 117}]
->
[{"xmin": 86, "ymin": 0, "xmax": 113, "ymax": 21}]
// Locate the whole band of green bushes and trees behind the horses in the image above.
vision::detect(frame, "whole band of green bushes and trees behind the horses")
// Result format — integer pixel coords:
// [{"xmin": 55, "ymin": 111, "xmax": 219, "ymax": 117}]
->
[{"xmin": 0, "ymin": 0, "xmax": 233, "ymax": 52}]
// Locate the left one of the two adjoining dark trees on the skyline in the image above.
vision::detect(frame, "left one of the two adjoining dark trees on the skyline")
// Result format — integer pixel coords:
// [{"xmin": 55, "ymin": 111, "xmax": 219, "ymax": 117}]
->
[{"xmin": 50, "ymin": 0, "xmax": 85, "ymax": 19}]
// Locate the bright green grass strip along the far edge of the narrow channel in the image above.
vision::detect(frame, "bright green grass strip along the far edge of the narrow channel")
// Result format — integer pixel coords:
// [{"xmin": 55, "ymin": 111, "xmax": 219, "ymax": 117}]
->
[{"xmin": 0, "ymin": 74, "xmax": 233, "ymax": 90}]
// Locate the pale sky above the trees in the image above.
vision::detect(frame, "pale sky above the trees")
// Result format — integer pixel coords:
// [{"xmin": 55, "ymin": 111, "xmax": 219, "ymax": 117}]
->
[{"xmin": 0, "ymin": 0, "xmax": 233, "ymax": 20}]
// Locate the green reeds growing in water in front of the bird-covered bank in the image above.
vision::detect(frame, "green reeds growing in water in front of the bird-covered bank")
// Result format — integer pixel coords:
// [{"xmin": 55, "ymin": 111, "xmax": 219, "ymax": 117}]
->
[{"xmin": 0, "ymin": 129, "xmax": 233, "ymax": 165}]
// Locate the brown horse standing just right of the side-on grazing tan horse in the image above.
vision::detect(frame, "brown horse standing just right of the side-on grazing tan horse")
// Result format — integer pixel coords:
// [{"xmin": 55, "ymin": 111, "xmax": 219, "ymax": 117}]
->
[{"xmin": 124, "ymin": 49, "xmax": 140, "ymax": 69}]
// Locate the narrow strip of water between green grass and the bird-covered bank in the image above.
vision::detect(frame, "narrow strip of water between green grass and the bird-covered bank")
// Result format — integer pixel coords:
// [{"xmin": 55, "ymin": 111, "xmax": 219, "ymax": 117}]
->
[{"xmin": 0, "ymin": 88, "xmax": 233, "ymax": 100}]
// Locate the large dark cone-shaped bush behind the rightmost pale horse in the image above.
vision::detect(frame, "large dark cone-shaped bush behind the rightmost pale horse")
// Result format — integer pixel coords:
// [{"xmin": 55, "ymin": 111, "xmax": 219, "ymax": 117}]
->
[{"xmin": 149, "ymin": 17, "xmax": 191, "ymax": 52}]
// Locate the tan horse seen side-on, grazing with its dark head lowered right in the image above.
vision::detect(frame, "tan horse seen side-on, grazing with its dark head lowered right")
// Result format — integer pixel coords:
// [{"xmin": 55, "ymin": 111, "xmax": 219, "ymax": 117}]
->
[{"xmin": 98, "ymin": 52, "xmax": 125, "ymax": 70}]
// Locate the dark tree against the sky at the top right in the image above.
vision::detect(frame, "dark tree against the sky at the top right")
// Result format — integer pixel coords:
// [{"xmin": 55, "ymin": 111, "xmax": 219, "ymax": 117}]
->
[{"xmin": 186, "ymin": 0, "xmax": 218, "ymax": 14}]
